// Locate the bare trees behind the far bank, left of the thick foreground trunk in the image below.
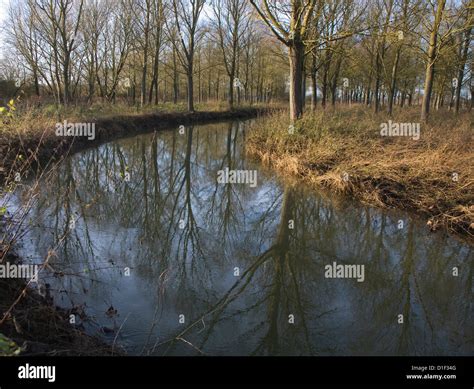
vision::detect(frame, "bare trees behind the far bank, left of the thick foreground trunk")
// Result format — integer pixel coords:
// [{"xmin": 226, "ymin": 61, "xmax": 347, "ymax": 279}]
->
[{"xmin": 2, "ymin": 0, "xmax": 285, "ymax": 111}]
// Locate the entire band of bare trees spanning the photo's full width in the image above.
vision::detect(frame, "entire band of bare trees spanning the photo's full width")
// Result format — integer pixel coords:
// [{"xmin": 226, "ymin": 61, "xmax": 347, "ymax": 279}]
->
[{"xmin": 2, "ymin": 0, "xmax": 474, "ymax": 120}]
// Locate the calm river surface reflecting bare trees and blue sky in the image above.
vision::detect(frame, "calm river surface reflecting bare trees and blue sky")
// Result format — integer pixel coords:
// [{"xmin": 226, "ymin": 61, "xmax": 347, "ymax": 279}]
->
[{"xmin": 12, "ymin": 122, "xmax": 473, "ymax": 355}]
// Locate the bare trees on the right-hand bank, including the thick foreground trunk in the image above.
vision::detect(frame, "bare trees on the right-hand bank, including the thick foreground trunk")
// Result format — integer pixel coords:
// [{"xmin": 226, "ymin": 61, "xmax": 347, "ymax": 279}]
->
[{"xmin": 250, "ymin": 0, "xmax": 474, "ymax": 120}]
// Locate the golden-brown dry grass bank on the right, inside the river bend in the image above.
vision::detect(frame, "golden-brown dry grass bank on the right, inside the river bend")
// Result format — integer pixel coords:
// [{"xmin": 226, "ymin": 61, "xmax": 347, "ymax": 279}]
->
[{"xmin": 247, "ymin": 106, "xmax": 474, "ymax": 240}]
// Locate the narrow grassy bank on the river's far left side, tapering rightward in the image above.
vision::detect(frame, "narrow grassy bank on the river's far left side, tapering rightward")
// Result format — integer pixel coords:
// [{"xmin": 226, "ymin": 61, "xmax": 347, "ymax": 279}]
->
[{"xmin": 0, "ymin": 107, "xmax": 269, "ymax": 183}]
